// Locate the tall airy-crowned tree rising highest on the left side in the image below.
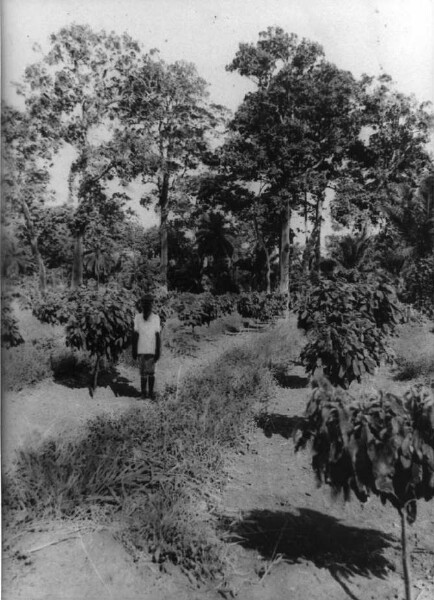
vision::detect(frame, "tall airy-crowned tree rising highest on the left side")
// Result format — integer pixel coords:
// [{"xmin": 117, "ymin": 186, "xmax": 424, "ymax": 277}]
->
[{"xmin": 18, "ymin": 25, "xmax": 145, "ymax": 287}]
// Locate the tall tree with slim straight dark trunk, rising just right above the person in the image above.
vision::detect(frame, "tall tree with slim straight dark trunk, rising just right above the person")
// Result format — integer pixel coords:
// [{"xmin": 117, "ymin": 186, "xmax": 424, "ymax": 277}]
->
[{"xmin": 121, "ymin": 56, "xmax": 225, "ymax": 287}]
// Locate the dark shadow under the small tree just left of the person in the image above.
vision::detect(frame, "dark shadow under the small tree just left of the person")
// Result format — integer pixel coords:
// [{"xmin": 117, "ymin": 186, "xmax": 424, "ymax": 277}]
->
[{"xmin": 54, "ymin": 365, "xmax": 140, "ymax": 398}]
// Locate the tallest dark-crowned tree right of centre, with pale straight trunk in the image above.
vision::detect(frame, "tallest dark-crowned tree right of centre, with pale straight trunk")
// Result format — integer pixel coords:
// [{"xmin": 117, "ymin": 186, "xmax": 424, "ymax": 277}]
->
[{"xmin": 227, "ymin": 28, "xmax": 359, "ymax": 293}]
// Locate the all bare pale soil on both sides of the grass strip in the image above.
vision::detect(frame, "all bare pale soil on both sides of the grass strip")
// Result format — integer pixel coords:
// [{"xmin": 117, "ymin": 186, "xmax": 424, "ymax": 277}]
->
[{"xmin": 2, "ymin": 326, "xmax": 434, "ymax": 600}]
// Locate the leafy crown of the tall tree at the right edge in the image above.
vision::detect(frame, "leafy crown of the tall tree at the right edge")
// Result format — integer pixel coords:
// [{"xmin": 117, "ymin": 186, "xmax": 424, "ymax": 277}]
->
[{"xmin": 331, "ymin": 75, "xmax": 433, "ymax": 229}]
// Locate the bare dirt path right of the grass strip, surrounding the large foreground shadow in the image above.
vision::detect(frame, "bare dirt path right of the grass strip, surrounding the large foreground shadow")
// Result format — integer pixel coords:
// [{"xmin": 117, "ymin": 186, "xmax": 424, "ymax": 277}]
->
[{"xmin": 219, "ymin": 360, "xmax": 434, "ymax": 600}]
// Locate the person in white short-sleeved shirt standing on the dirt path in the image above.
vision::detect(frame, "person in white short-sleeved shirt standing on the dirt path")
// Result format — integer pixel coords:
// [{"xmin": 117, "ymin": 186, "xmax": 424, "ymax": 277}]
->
[{"xmin": 133, "ymin": 295, "xmax": 161, "ymax": 399}]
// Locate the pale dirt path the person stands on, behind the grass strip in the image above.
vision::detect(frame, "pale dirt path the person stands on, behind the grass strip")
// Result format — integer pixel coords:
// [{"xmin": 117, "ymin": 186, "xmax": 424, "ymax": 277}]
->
[{"xmin": 2, "ymin": 326, "xmax": 251, "ymax": 468}]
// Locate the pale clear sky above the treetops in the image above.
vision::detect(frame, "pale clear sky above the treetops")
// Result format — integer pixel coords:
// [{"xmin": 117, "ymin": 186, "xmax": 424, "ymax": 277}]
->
[{"xmin": 2, "ymin": 0, "xmax": 434, "ymax": 227}]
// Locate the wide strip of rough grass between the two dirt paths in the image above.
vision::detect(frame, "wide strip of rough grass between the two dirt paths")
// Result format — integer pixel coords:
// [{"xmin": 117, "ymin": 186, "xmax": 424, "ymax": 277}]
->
[{"xmin": 3, "ymin": 334, "xmax": 278, "ymax": 580}]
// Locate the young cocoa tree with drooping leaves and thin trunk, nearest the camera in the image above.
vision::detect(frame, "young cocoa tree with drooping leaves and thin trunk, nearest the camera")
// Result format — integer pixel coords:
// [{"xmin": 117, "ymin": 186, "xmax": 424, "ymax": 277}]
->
[{"xmin": 296, "ymin": 379, "xmax": 434, "ymax": 600}]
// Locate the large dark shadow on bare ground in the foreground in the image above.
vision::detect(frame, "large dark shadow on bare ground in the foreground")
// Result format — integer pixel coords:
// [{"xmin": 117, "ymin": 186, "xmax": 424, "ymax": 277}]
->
[{"xmin": 222, "ymin": 508, "xmax": 395, "ymax": 587}]
